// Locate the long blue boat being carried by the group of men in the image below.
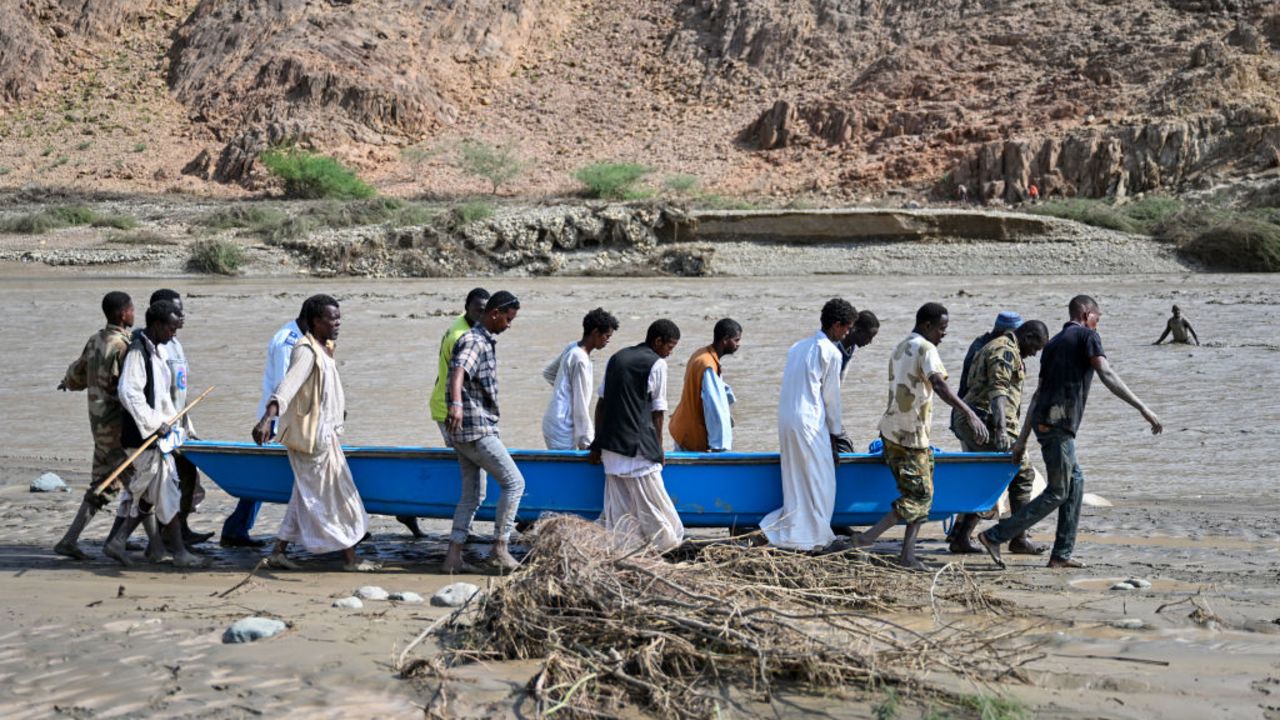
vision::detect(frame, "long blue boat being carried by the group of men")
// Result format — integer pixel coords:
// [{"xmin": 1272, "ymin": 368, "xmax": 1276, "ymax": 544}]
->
[{"xmin": 182, "ymin": 441, "xmax": 1018, "ymax": 528}]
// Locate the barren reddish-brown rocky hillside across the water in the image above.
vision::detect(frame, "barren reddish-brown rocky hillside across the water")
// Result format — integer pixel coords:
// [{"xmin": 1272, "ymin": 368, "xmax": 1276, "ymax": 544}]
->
[{"xmin": 0, "ymin": 0, "xmax": 1280, "ymax": 201}]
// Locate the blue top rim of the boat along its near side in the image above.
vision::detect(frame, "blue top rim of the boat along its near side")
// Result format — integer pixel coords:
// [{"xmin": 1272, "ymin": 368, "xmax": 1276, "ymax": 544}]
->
[{"xmin": 183, "ymin": 441, "xmax": 1012, "ymax": 466}]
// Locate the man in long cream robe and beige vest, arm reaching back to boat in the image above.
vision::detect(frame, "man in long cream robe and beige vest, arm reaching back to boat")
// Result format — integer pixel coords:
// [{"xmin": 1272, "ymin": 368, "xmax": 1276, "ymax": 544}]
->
[{"xmin": 252, "ymin": 295, "xmax": 381, "ymax": 573}]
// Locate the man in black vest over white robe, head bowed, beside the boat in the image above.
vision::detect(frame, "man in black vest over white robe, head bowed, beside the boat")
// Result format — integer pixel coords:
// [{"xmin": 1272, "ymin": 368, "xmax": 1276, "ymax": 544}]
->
[{"xmin": 590, "ymin": 319, "xmax": 685, "ymax": 552}]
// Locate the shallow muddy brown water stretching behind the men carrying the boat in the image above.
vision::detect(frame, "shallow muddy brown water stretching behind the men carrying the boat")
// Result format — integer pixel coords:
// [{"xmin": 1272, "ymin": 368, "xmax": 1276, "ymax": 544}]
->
[{"xmin": 0, "ymin": 273, "xmax": 1280, "ymax": 502}]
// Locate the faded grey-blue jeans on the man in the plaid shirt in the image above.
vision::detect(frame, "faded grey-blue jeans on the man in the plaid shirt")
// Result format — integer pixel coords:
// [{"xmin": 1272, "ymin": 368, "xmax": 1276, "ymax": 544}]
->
[{"xmin": 449, "ymin": 436, "xmax": 525, "ymax": 543}]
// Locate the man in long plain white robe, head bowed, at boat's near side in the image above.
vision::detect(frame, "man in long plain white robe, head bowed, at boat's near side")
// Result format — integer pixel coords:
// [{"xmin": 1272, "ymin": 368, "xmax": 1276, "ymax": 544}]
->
[{"xmin": 760, "ymin": 297, "xmax": 858, "ymax": 550}]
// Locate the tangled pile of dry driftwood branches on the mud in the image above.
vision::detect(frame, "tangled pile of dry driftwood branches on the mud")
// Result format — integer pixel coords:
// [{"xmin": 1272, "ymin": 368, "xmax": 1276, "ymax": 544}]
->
[{"xmin": 398, "ymin": 516, "xmax": 1030, "ymax": 717}]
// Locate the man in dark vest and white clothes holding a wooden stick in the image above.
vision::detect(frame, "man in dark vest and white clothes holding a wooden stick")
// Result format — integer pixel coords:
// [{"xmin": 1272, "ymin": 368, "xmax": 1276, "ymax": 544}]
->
[{"xmin": 102, "ymin": 300, "xmax": 204, "ymax": 568}]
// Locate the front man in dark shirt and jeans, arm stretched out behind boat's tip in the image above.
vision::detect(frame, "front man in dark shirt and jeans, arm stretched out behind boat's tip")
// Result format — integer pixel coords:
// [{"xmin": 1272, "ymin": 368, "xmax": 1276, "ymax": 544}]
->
[{"xmin": 978, "ymin": 295, "xmax": 1164, "ymax": 569}]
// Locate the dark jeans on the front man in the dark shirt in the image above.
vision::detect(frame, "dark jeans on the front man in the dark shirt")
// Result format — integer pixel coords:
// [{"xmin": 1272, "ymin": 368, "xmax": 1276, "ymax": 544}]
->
[{"xmin": 986, "ymin": 428, "xmax": 1084, "ymax": 560}]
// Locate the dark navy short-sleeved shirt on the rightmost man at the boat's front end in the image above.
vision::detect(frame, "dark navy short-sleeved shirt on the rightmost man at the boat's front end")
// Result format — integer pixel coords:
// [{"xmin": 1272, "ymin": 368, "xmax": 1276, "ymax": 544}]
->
[{"xmin": 1029, "ymin": 323, "xmax": 1106, "ymax": 436}]
